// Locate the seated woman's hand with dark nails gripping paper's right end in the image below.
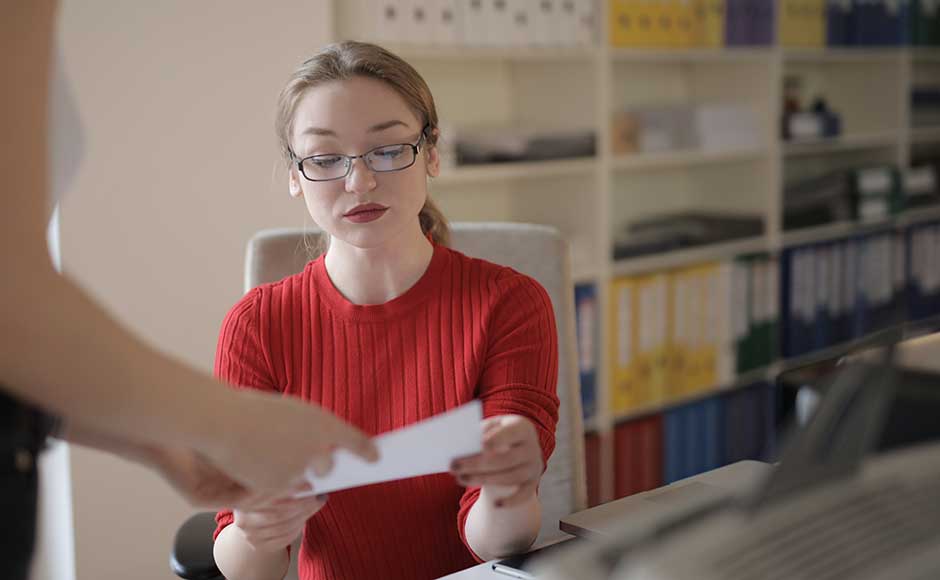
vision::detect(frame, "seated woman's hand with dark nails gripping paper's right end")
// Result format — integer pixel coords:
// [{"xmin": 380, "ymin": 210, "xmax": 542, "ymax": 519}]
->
[{"xmin": 451, "ymin": 415, "xmax": 543, "ymax": 507}]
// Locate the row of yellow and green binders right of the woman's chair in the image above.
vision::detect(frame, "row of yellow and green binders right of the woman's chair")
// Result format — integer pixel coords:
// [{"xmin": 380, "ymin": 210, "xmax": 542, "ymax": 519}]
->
[{"xmin": 609, "ymin": 254, "xmax": 779, "ymax": 416}]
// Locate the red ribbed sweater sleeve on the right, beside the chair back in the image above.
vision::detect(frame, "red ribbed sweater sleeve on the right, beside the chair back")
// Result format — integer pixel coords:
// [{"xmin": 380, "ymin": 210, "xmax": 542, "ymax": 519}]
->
[{"xmin": 457, "ymin": 272, "xmax": 558, "ymax": 560}]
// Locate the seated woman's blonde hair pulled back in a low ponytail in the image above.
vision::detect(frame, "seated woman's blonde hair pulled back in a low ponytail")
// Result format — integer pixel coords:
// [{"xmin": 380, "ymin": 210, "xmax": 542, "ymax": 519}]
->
[{"xmin": 274, "ymin": 41, "xmax": 450, "ymax": 250}]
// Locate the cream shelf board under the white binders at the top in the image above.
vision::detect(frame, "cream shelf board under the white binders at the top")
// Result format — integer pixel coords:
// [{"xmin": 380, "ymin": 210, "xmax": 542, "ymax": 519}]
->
[{"xmin": 380, "ymin": 45, "xmax": 598, "ymax": 63}]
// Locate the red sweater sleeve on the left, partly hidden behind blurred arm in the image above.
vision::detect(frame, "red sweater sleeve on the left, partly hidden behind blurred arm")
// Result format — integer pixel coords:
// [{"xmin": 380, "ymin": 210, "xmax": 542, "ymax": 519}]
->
[{"xmin": 212, "ymin": 288, "xmax": 278, "ymax": 540}]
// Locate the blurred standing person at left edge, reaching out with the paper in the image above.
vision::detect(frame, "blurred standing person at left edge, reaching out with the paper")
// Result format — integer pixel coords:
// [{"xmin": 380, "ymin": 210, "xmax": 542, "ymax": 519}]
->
[{"xmin": 0, "ymin": 5, "xmax": 375, "ymax": 580}]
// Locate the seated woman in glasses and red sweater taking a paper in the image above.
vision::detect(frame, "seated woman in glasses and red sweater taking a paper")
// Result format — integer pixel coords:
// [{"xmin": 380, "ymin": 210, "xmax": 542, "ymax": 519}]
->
[{"xmin": 215, "ymin": 42, "xmax": 558, "ymax": 580}]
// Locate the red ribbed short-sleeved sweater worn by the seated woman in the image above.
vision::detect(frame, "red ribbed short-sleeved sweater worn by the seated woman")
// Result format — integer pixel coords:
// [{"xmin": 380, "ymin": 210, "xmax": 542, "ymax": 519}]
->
[{"xmin": 215, "ymin": 246, "xmax": 558, "ymax": 580}]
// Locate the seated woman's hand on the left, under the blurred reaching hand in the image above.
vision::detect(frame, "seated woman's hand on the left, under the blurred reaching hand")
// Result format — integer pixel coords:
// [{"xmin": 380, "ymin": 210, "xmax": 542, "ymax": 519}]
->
[{"xmin": 232, "ymin": 496, "xmax": 326, "ymax": 554}]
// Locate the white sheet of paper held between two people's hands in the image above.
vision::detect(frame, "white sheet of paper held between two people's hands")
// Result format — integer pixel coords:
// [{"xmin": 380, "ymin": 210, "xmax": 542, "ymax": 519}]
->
[{"xmin": 296, "ymin": 401, "xmax": 483, "ymax": 497}]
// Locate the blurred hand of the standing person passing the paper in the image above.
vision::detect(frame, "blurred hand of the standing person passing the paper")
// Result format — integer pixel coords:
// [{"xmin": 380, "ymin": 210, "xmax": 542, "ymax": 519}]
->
[{"xmin": 201, "ymin": 390, "xmax": 378, "ymax": 497}]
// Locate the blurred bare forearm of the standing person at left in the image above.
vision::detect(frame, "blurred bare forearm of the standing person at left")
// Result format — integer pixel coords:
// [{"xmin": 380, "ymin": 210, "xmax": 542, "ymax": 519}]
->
[{"xmin": 0, "ymin": 261, "xmax": 235, "ymax": 454}]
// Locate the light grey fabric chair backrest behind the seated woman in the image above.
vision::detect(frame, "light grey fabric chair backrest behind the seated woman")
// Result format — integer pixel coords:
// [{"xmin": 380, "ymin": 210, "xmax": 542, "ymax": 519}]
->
[{"xmin": 245, "ymin": 223, "xmax": 586, "ymax": 543}]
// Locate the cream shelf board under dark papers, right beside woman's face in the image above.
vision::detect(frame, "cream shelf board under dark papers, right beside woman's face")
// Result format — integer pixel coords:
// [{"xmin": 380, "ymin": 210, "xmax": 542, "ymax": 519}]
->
[{"xmin": 431, "ymin": 157, "xmax": 597, "ymax": 186}]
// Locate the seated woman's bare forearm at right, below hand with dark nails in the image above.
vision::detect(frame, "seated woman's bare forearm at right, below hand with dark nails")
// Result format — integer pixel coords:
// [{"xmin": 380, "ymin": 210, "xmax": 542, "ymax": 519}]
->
[{"xmin": 464, "ymin": 486, "xmax": 542, "ymax": 560}]
